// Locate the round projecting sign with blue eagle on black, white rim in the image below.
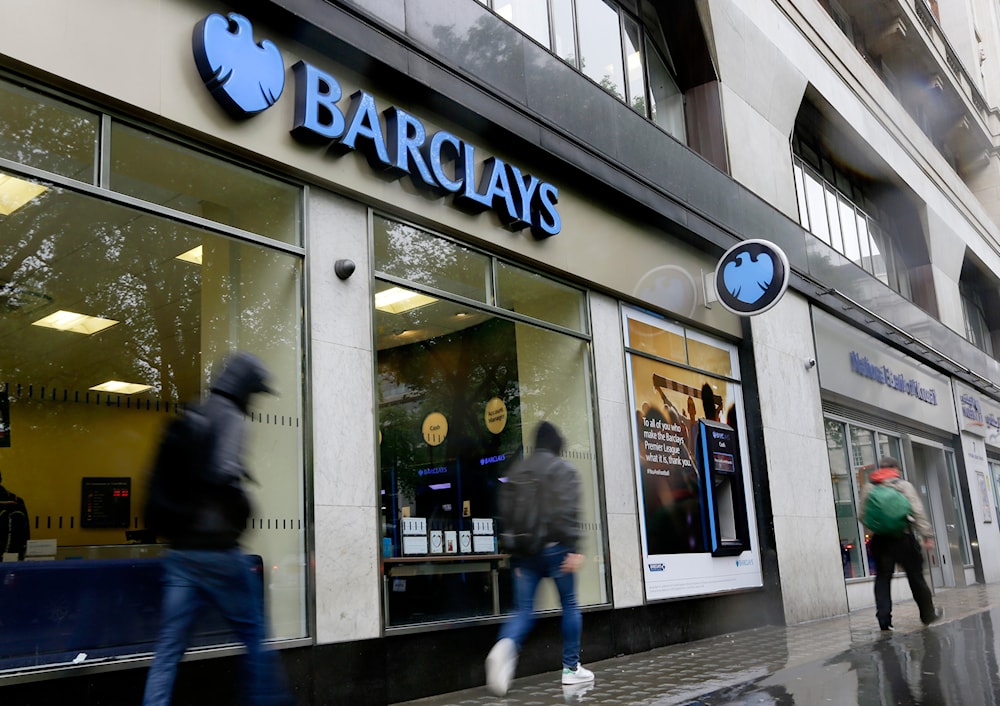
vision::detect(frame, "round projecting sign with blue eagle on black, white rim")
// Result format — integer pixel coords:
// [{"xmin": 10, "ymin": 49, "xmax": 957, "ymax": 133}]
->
[{"xmin": 715, "ymin": 240, "xmax": 790, "ymax": 316}]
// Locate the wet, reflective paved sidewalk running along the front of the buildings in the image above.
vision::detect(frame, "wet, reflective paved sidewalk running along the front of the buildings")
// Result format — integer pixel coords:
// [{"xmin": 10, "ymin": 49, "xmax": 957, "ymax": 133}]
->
[{"xmin": 399, "ymin": 579, "xmax": 1000, "ymax": 706}]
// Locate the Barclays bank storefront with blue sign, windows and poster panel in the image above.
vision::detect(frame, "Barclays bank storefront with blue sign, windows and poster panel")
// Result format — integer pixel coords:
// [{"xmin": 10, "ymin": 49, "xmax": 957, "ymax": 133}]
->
[{"xmin": 0, "ymin": 0, "xmax": 788, "ymax": 704}]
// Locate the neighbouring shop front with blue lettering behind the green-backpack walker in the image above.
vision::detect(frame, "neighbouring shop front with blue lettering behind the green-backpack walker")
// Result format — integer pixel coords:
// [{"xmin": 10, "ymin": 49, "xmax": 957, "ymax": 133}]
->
[{"xmin": 812, "ymin": 308, "xmax": 975, "ymax": 610}]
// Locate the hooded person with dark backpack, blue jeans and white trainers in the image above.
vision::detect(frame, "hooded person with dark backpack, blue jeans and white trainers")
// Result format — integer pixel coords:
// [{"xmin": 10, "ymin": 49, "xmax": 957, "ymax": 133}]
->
[{"xmin": 486, "ymin": 422, "xmax": 594, "ymax": 696}]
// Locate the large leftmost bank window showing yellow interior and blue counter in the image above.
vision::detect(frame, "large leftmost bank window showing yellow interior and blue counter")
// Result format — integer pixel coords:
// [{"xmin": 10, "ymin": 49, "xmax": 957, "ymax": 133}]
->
[{"xmin": 0, "ymin": 74, "xmax": 307, "ymax": 672}]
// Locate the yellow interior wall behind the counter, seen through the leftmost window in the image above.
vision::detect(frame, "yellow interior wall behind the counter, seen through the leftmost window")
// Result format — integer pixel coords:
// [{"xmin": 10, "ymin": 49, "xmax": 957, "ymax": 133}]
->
[{"xmin": 0, "ymin": 389, "xmax": 170, "ymax": 546}]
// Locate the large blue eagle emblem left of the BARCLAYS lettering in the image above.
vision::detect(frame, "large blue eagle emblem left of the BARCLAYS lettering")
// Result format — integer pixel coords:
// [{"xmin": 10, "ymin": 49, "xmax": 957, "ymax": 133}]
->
[{"xmin": 193, "ymin": 13, "xmax": 285, "ymax": 118}]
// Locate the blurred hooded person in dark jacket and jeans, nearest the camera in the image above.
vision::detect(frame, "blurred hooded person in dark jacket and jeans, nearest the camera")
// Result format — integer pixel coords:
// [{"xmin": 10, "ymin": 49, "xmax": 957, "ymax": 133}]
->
[{"xmin": 143, "ymin": 352, "xmax": 293, "ymax": 706}]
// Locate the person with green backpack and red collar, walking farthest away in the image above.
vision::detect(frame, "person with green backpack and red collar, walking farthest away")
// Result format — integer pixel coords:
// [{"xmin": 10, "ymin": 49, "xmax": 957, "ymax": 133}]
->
[{"xmin": 861, "ymin": 456, "xmax": 941, "ymax": 630}]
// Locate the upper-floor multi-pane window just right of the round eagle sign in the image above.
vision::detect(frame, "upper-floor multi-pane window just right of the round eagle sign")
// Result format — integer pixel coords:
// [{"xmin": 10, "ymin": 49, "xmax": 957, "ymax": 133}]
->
[{"xmin": 792, "ymin": 134, "xmax": 911, "ymax": 299}]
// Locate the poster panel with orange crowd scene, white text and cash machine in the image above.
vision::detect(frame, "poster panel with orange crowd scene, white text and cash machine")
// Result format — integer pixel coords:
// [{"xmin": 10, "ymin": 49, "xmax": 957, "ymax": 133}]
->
[{"xmin": 623, "ymin": 308, "xmax": 762, "ymax": 600}]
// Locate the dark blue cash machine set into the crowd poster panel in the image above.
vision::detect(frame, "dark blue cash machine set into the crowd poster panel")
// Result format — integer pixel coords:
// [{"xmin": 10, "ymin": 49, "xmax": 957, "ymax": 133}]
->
[{"xmin": 695, "ymin": 419, "xmax": 750, "ymax": 556}]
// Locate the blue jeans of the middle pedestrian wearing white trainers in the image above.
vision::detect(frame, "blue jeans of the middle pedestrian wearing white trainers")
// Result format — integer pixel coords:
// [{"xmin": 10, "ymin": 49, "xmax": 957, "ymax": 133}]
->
[{"xmin": 500, "ymin": 544, "xmax": 583, "ymax": 669}]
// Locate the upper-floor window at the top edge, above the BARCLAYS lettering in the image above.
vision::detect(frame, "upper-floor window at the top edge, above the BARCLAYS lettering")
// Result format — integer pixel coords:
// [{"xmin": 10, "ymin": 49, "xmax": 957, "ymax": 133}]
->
[{"xmin": 479, "ymin": 0, "xmax": 687, "ymax": 142}]
